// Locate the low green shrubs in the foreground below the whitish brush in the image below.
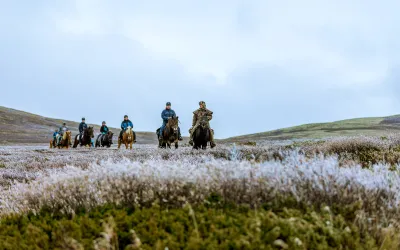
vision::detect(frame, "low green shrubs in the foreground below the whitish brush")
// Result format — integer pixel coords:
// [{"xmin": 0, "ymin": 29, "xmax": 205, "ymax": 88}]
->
[{"xmin": 0, "ymin": 200, "xmax": 392, "ymax": 249}]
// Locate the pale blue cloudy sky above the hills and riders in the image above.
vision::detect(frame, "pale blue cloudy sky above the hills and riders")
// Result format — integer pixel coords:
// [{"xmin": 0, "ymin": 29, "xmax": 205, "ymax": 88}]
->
[{"xmin": 0, "ymin": 0, "xmax": 400, "ymax": 138}]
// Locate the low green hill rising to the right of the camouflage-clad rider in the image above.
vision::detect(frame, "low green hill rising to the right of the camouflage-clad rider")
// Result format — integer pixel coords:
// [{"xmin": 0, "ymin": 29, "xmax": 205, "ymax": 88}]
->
[{"xmin": 223, "ymin": 115, "xmax": 400, "ymax": 142}]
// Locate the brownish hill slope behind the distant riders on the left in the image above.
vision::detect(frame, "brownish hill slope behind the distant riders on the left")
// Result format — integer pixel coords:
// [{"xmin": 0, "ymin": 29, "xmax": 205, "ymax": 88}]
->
[{"xmin": 0, "ymin": 106, "xmax": 157, "ymax": 144}]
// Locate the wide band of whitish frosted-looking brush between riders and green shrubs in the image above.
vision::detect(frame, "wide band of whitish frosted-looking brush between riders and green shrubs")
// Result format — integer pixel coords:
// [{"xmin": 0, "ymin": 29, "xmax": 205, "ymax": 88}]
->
[{"xmin": 0, "ymin": 143, "xmax": 400, "ymax": 229}]
